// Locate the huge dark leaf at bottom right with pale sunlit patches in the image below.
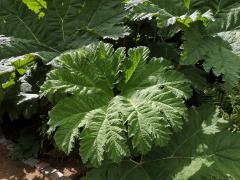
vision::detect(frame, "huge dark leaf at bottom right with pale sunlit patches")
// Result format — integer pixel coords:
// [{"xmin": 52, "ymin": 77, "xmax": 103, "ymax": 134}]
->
[{"xmin": 86, "ymin": 105, "xmax": 240, "ymax": 180}]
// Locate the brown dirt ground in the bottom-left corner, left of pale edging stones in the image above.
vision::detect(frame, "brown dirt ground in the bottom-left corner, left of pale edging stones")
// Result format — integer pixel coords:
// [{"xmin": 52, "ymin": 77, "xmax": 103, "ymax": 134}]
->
[{"xmin": 0, "ymin": 145, "xmax": 48, "ymax": 180}]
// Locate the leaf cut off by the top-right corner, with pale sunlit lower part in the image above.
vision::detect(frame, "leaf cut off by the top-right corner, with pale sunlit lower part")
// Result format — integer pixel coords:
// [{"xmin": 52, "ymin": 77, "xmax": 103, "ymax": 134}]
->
[{"xmin": 192, "ymin": 0, "xmax": 240, "ymax": 55}]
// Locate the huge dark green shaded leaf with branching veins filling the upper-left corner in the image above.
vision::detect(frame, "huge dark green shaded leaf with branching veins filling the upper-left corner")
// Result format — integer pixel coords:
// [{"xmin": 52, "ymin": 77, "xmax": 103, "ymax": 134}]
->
[{"xmin": 0, "ymin": 0, "xmax": 129, "ymax": 54}]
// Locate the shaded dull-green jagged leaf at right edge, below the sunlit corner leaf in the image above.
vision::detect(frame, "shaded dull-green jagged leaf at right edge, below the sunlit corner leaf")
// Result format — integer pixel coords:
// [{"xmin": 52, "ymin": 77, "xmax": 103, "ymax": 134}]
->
[{"xmin": 182, "ymin": 25, "xmax": 240, "ymax": 90}]
